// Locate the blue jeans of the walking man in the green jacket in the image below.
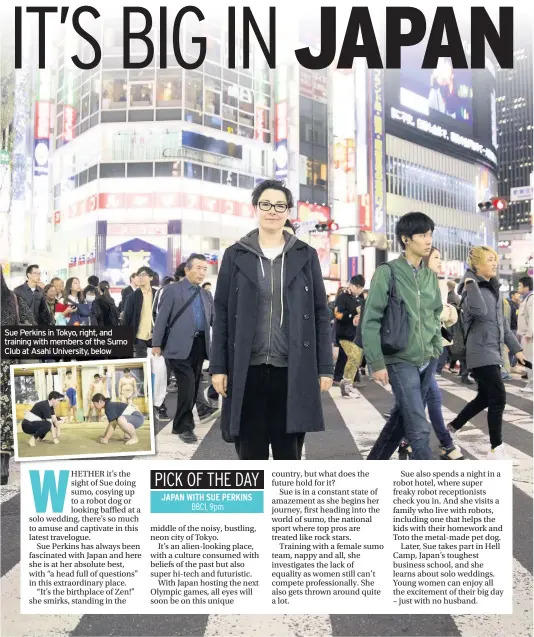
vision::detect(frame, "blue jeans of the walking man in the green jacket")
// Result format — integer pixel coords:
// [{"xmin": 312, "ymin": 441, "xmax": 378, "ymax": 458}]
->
[{"xmin": 367, "ymin": 358, "xmax": 438, "ymax": 460}]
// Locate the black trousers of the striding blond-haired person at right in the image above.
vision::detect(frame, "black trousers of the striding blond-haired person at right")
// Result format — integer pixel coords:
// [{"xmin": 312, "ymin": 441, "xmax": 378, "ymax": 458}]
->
[{"xmin": 451, "ymin": 365, "xmax": 506, "ymax": 449}]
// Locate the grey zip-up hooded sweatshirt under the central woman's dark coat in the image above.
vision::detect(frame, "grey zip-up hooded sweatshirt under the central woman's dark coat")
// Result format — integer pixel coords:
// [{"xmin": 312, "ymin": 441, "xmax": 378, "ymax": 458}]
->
[{"xmin": 239, "ymin": 230, "xmax": 297, "ymax": 367}]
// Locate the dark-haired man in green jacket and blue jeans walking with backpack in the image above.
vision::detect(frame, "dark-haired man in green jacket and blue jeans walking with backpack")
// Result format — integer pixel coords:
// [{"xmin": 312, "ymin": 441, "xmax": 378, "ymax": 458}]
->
[{"xmin": 362, "ymin": 212, "xmax": 442, "ymax": 460}]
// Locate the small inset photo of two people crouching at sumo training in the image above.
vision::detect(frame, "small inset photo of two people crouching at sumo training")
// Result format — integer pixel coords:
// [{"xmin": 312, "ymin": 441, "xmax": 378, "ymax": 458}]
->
[{"xmin": 11, "ymin": 359, "xmax": 155, "ymax": 461}]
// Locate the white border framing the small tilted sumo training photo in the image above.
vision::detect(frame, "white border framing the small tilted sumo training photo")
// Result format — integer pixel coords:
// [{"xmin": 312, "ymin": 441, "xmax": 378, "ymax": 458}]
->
[{"xmin": 10, "ymin": 358, "xmax": 156, "ymax": 462}]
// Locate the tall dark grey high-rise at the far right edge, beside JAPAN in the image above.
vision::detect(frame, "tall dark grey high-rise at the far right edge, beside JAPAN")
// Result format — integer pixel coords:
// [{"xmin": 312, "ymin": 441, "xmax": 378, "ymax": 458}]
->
[{"xmin": 497, "ymin": 36, "xmax": 534, "ymax": 230}]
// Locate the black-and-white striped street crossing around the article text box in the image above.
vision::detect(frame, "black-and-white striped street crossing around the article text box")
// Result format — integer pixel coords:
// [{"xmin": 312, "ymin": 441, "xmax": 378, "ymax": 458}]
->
[{"xmin": 0, "ymin": 374, "xmax": 533, "ymax": 637}]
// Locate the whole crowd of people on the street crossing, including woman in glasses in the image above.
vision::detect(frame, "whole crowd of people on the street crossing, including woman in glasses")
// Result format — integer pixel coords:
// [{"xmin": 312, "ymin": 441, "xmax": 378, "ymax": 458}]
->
[{"xmin": 2, "ymin": 180, "xmax": 533, "ymax": 468}]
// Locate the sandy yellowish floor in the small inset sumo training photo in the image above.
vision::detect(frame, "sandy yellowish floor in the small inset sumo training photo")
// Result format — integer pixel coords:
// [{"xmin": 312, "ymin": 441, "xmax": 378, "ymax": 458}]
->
[{"xmin": 17, "ymin": 419, "xmax": 154, "ymax": 458}]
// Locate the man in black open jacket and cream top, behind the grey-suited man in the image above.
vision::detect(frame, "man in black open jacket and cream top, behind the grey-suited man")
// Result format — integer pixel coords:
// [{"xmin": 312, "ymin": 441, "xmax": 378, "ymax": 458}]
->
[{"xmin": 124, "ymin": 266, "xmax": 157, "ymax": 358}]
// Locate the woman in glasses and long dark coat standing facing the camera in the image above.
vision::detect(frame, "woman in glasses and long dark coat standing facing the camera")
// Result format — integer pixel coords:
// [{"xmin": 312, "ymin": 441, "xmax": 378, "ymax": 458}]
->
[{"xmin": 210, "ymin": 180, "xmax": 334, "ymax": 460}]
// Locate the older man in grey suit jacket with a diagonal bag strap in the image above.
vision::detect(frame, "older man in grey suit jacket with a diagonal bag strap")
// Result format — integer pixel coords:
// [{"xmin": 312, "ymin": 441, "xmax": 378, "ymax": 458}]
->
[{"xmin": 152, "ymin": 254, "xmax": 213, "ymax": 444}]
